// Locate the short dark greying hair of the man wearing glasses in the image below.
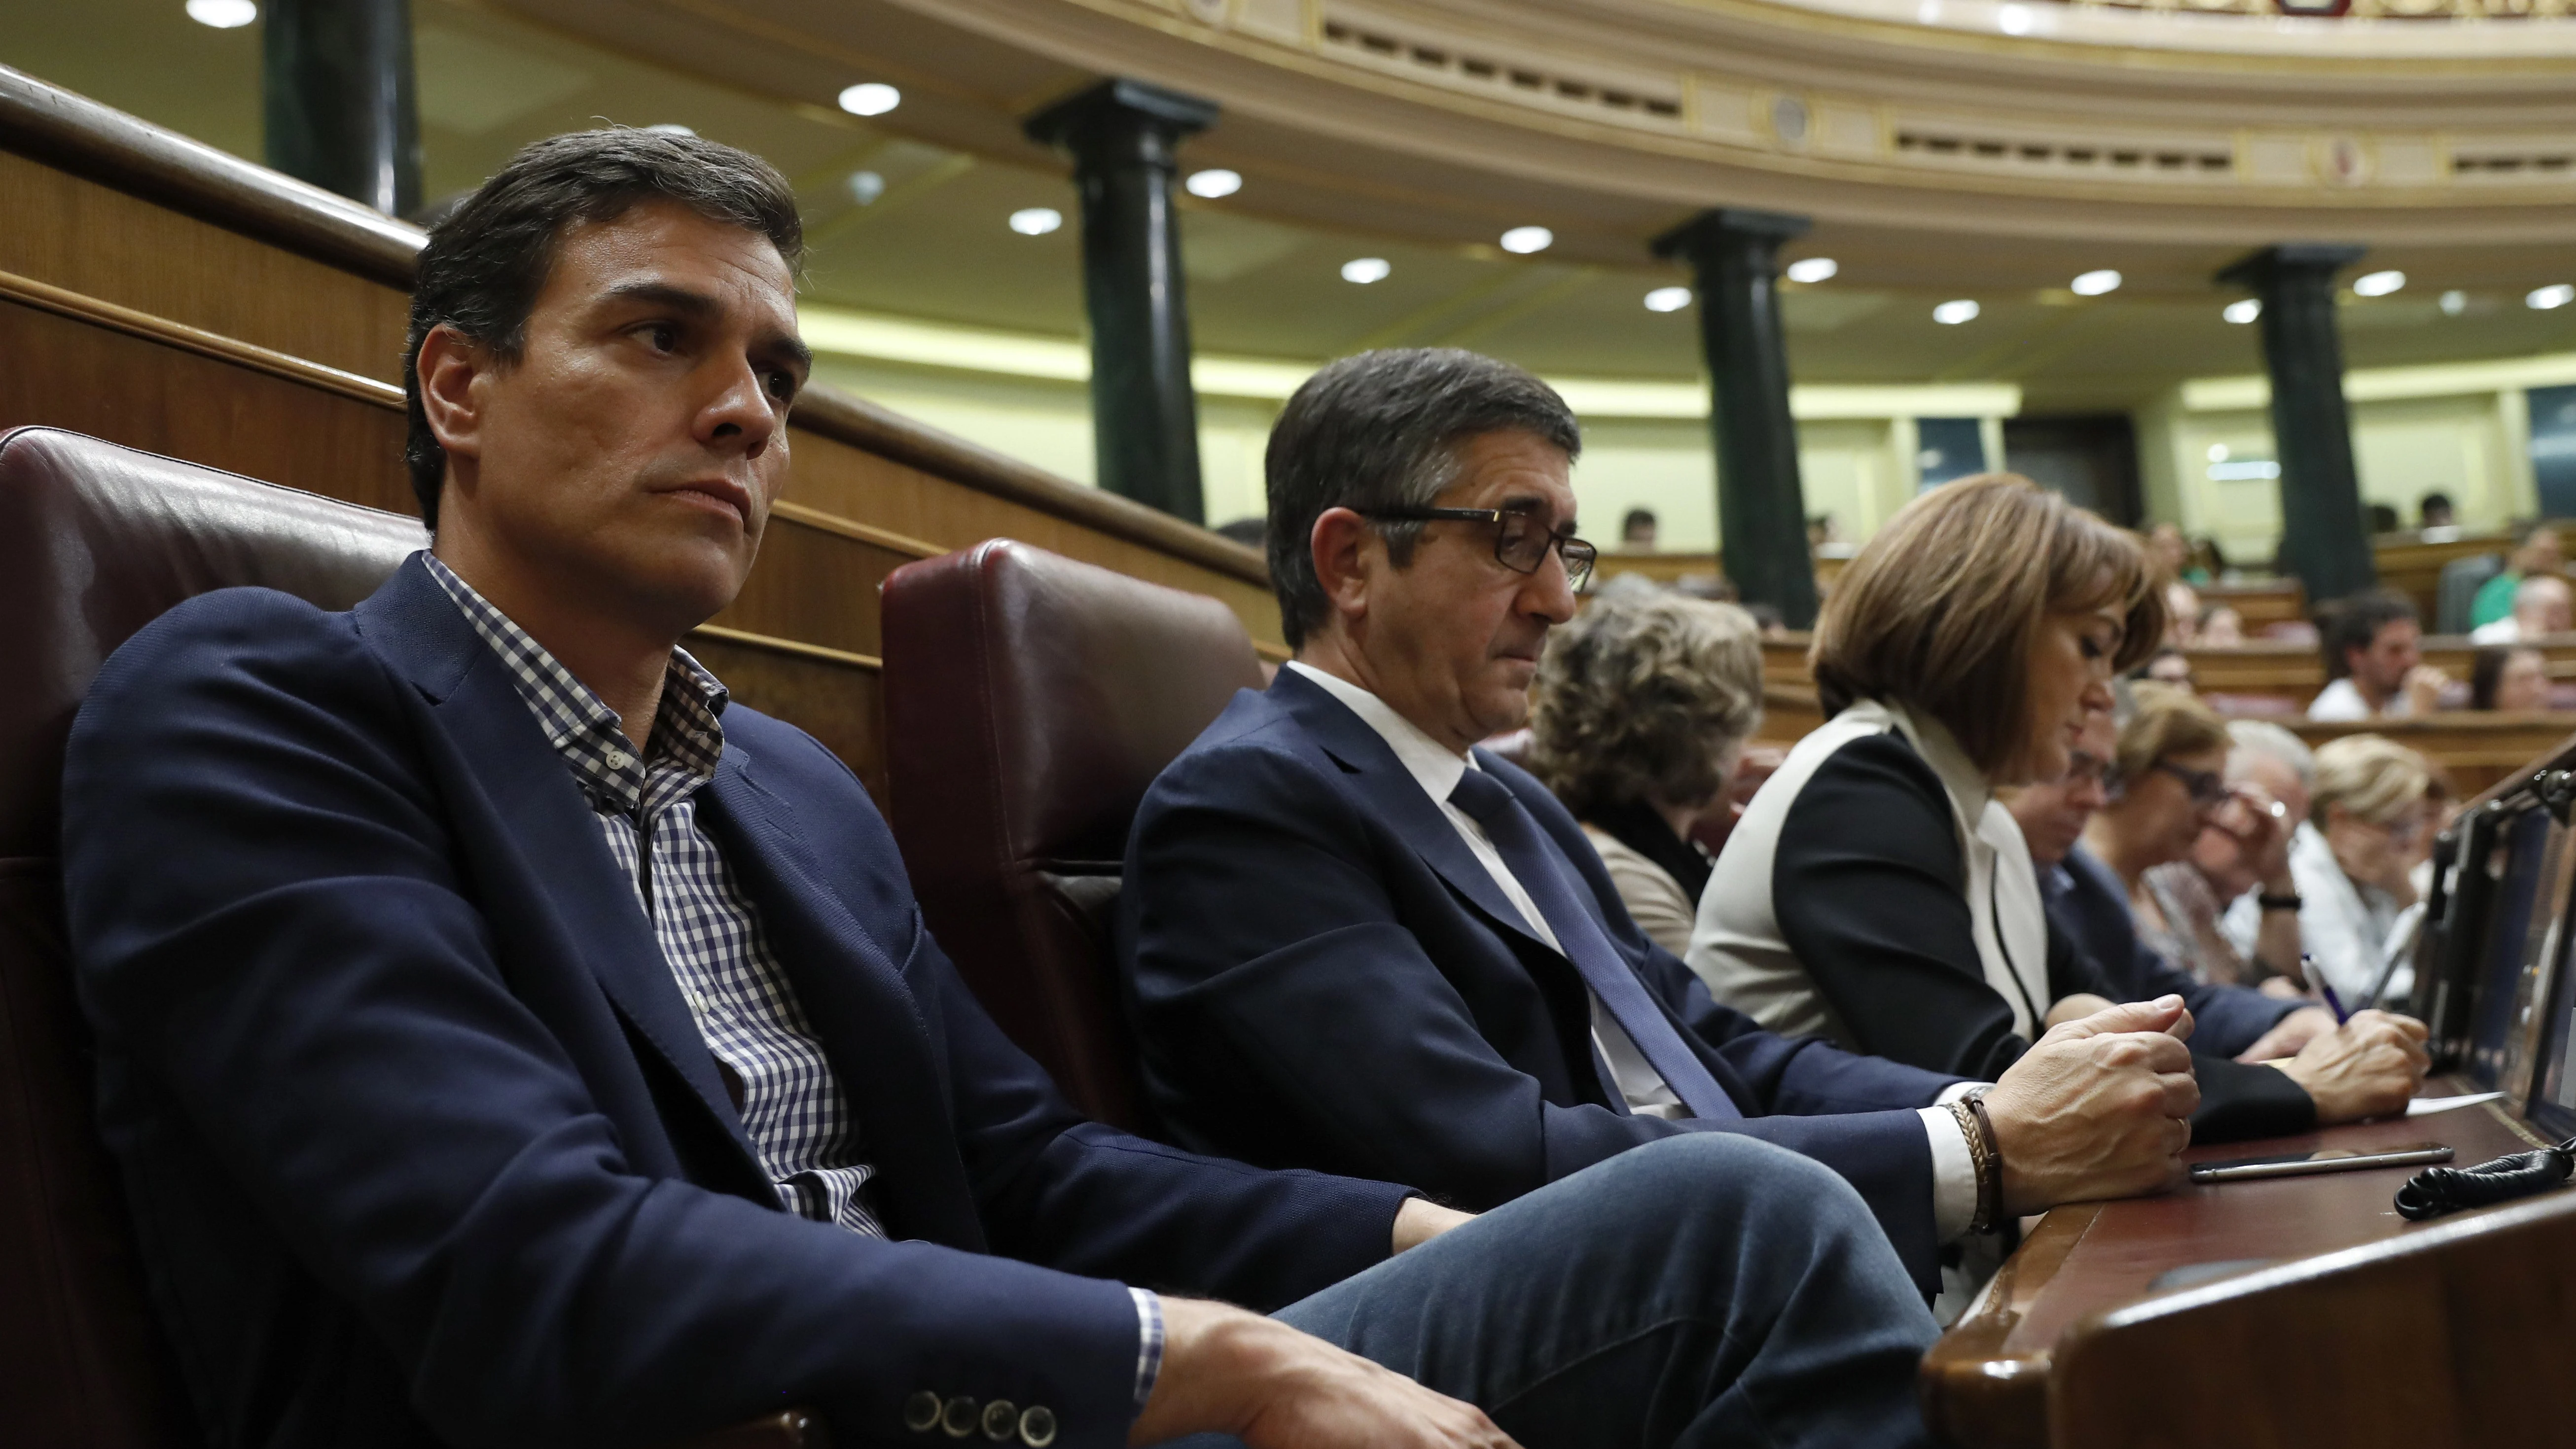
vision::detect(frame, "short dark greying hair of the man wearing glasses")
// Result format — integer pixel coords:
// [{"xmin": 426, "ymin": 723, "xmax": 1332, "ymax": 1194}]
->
[{"xmin": 1262, "ymin": 348, "xmax": 1584, "ymax": 649}]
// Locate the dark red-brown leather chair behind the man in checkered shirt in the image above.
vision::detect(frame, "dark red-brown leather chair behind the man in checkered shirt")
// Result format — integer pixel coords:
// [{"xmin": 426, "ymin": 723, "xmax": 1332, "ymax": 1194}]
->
[{"xmin": 0, "ymin": 427, "xmax": 806, "ymax": 1449}]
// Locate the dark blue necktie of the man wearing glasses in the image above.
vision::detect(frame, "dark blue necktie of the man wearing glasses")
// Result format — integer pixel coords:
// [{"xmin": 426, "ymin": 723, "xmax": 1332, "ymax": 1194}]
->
[{"xmin": 1450, "ymin": 770, "xmax": 1744, "ymax": 1122}]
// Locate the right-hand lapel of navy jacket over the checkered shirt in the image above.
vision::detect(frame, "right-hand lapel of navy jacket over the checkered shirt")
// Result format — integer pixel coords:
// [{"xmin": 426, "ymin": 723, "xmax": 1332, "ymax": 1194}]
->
[{"xmin": 698, "ymin": 744, "xmax": 984, "ymax": 1251}]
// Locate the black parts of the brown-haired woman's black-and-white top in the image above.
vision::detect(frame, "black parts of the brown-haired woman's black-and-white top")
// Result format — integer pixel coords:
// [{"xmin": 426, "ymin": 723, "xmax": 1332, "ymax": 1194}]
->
[{"xmin": 1752, "ymin": 731, "xmax": 2316, "ymax": 1143}]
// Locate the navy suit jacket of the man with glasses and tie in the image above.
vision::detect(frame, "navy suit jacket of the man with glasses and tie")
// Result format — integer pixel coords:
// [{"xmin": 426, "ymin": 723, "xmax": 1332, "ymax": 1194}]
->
[{"xmin": 1118, "ymin": 669, "xmax": 1955, "ymax": 1284}]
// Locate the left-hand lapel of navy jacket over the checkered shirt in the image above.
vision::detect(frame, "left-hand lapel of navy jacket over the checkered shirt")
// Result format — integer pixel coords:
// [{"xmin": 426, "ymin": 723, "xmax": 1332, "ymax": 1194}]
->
[{"xmin": 358, "ymin": 559, "xmax": 768, "ymax": 1181}]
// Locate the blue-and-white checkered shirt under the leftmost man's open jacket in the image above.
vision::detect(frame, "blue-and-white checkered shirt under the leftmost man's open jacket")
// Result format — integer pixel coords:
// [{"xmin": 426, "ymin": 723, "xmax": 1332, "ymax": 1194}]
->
[{"xmin": 423, "ymin": 553, "xmax": 884, "ymax": 1236}]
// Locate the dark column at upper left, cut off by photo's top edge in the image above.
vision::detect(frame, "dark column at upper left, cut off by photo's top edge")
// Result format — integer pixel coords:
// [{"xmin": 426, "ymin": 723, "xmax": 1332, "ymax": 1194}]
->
[{"xmin": 260, "ymin": 0, "xmax": 420, "ymax": 216}]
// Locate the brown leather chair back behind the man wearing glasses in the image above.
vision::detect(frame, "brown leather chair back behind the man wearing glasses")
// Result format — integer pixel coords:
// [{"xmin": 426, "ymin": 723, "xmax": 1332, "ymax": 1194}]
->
[{"xmin": 881, "ymin": 538, "xmax": 1262, "ymax": 1130}]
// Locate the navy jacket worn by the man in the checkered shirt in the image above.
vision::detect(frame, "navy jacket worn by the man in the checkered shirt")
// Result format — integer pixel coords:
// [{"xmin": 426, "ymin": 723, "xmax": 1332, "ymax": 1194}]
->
[{"xmin": 65, "ymin": 559, "xmax": 1404, "ymax": 1447}]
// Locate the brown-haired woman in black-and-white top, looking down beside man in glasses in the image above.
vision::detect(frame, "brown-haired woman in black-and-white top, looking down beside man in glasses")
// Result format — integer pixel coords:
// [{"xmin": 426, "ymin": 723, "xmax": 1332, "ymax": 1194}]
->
[{"xmin": 1690, "ymin": 474, "xmax": 2393, "ymax": 1140}]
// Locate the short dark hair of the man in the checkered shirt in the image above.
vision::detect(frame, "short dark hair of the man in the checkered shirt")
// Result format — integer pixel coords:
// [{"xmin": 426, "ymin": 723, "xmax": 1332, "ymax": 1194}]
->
[{"xmin": 402, "ymin": 126, "xmax": 804, "ymax": 528}]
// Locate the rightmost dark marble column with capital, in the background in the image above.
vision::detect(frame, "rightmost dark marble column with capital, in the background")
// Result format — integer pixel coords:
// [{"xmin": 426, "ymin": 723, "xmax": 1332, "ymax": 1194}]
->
[{"xmin": 2218, "ymin": 242, "xmax": 2380, "ymax": 602}]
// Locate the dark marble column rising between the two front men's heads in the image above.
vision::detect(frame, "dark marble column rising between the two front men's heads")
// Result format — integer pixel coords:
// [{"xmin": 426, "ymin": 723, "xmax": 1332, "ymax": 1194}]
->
[{"xmin": 1028, "ymin": 80, "xmax": 1216, "ymax": 523}]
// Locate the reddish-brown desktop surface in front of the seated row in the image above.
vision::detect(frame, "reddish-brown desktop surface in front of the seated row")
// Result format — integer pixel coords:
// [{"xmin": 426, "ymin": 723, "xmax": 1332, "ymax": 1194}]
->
[{"xmin": 1922, "ymin": 1078, "xmax": 2542, "ymax": 1449}]
